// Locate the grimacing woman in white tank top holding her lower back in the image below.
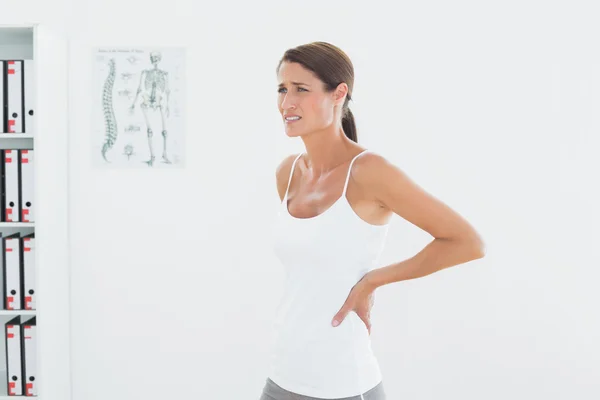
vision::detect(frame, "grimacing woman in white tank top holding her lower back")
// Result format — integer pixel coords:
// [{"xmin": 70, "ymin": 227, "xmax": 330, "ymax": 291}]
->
[{"xmin": 261, "ymin": 42, "xmax": 484, "ymax": 400}]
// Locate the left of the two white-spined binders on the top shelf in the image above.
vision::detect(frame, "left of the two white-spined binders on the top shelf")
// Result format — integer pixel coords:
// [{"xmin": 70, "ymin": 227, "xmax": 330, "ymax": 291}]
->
[{"xmin": 5, "ymin": 60, "xmax": 25, "ymax": 133}]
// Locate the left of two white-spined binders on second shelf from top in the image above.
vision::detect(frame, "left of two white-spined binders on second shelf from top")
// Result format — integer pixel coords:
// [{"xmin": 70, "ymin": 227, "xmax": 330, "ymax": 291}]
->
[{"xmin": 0, "ymin": 149, "xmax": 20, "ymax": 222}]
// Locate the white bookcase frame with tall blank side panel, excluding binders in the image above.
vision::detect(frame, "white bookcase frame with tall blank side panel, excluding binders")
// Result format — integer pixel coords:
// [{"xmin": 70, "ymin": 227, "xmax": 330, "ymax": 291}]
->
[{"xmin": 0, "ymin": 21, "xmax": 71, "ymax": 400}]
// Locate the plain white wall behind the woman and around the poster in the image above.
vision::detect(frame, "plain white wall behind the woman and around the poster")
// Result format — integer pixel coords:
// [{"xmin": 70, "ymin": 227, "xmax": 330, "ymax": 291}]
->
[{"xmin": 21, "ymin": 0, "xmax": 600, "ymax": 400}]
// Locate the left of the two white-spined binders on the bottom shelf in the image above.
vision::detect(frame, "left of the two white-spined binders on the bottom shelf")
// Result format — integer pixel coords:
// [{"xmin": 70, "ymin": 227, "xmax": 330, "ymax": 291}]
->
[{"xmin": 4, "ymin": 316, "xmax": 23, "ymax": 396}]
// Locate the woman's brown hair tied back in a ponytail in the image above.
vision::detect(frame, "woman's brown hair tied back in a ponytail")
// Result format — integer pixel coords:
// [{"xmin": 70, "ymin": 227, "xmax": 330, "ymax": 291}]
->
[{"xmin": 277, "ymin": 42, "xmax": 358, "ymax": 142}]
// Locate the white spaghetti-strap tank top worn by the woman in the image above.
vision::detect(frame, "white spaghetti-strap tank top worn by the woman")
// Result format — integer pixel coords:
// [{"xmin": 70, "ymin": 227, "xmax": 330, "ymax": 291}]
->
[{"xmin": 269, "ymin": 150, "xmax": 389, "ymax": 399}]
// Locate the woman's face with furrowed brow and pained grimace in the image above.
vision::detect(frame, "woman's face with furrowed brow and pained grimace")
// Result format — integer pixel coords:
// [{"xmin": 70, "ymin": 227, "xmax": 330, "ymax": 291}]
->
[{"xmin": 277, "ymin": 62, "xmax": 335, "ymax": 136}]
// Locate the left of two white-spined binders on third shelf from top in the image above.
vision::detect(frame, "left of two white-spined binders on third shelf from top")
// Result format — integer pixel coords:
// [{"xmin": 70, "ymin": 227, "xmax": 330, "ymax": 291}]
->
[{"xmin": 2, "ymin": 233, "xmax": 23, "ymax": 310}]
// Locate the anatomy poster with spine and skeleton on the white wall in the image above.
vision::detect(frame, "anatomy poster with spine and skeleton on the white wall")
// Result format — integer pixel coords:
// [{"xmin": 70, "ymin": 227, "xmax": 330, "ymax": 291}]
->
[{"xmin": 92, "ymin": 47, "xmax": 185, "ymax": 169}]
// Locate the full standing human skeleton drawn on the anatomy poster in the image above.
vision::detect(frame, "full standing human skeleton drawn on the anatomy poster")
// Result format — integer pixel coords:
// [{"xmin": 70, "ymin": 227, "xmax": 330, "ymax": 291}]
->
[{"xmin": 129, "ymin": 52, "xmax": 171, "ymax": 166}]
